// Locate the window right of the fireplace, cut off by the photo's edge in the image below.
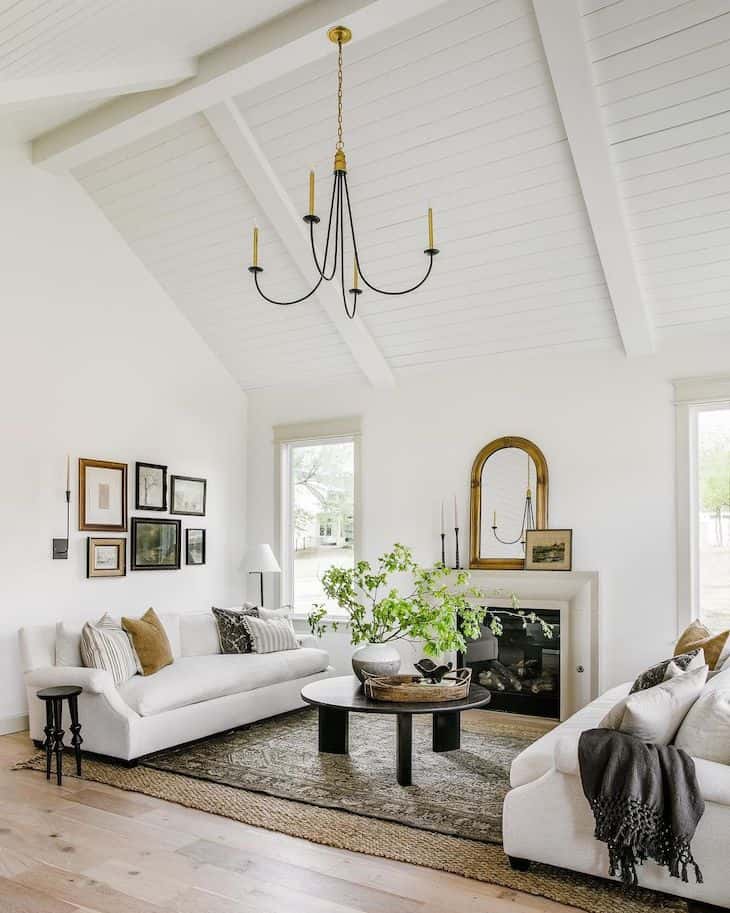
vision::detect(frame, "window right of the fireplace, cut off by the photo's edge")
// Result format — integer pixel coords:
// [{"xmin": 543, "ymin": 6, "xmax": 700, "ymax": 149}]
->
[{"xmin": 675, "ymin": 378, "xmax": 730, "ymax": 631}]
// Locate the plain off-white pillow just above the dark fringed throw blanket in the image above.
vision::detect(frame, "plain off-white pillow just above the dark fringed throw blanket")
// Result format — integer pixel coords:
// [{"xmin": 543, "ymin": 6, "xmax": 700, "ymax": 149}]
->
[{"xmin": 599, "ymin": 666, "xmax": 709, "ymax": 745}]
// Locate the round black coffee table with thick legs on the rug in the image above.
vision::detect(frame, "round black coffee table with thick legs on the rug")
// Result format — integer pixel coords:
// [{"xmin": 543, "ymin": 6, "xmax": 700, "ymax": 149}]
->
[{"xmin": 302, "ymin": 675, "xmax": 492, "ymax": 786}]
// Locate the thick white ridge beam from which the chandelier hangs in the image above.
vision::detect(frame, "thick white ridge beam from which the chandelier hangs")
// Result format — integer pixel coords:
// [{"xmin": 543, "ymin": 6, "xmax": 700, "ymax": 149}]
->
[{"xmin": 32, "ymin": 0, "xmax": 444, "ymax": 172}]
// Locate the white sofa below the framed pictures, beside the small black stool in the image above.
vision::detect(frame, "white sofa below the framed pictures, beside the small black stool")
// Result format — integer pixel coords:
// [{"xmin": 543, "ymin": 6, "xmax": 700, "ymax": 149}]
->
[{"xmin": 20, "ymin": 611, "xmax": 334, "ymax": 761}]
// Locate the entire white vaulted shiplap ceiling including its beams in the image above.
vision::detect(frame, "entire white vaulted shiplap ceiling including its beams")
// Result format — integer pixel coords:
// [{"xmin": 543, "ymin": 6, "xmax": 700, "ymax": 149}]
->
[{"xmin": 5, "ymin": 0, "xmax": 730, "ymax": 389}]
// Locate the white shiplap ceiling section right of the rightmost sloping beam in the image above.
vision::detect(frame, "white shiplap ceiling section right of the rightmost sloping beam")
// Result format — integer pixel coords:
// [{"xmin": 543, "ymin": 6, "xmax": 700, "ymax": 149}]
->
[{"xmin": 583, "ymin": 0, "xmax": 730, "ymax": 340}]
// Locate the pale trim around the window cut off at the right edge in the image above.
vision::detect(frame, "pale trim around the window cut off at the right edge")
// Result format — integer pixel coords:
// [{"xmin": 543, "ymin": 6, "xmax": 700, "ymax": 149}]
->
[{"xmin": 674, "ymin": 376, "xmax": 730, "ymax": 633}]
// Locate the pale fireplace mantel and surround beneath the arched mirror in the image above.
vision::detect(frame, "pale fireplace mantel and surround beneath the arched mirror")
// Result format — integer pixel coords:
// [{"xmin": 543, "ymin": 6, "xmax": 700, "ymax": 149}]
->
[{"xmin": 470, "ymin": 570, "xmax": 600, "ymax": 719}]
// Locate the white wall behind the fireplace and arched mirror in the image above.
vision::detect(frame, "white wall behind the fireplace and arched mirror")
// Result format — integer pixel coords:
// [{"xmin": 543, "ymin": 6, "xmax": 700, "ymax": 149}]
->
[{"xmin": 248, "ymin": 340, "xmax": 727, "ymax": 686}]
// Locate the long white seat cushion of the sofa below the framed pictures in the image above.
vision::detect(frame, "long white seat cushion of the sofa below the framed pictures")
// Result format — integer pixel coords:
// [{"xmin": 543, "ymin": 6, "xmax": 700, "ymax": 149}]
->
[{"xmin": 119, "ymin": 648, "xmax": 329, "ymax": 716}]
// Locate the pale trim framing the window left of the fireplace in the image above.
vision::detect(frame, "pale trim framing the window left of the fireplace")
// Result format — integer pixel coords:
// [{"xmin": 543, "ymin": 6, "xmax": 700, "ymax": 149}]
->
[{"xmin": 274, "ymin": 416, "xmax": 362, "ymax": 621}]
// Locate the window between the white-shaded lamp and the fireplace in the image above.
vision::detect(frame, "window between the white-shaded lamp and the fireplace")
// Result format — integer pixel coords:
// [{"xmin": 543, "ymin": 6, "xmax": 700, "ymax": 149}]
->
[{"xmin": 276, "ymin": 420, "xmax": 358, "ymax": 614}]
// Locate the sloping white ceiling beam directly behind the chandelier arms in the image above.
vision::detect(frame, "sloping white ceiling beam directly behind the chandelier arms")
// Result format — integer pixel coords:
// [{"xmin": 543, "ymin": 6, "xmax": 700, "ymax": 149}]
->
[{"xmin": 205, "ymin": 99, "xmax": 395, "ymax": 387}]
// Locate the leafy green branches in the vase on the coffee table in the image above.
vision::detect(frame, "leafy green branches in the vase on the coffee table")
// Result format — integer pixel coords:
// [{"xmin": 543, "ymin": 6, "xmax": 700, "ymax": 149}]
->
[{"xmin": 308, "ymin": 543, "xmax": 552, "ymax": 656}]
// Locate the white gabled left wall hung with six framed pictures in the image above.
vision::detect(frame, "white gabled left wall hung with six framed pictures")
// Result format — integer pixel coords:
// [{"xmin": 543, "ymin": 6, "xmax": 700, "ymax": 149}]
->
[{"xmin": 0, "ymin": 149, "xmax": 246, "ymax": 725}]
